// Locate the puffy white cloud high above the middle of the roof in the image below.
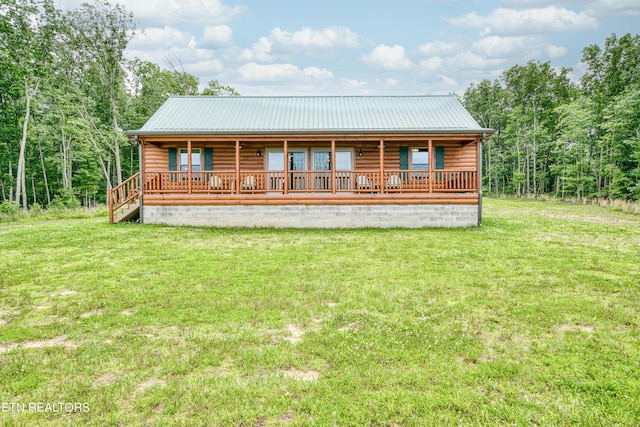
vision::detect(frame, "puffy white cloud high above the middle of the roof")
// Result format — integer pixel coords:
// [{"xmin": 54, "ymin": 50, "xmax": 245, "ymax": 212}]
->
[{"xmin": 270, "ymin": 26, "xmax": 360, "ymax": 49}]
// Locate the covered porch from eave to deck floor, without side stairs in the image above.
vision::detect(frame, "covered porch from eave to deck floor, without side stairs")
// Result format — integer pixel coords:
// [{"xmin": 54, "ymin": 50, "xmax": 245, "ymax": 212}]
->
[{"xmin": 142, "ymin": 137, "xmax": 478, "ymax": 199}]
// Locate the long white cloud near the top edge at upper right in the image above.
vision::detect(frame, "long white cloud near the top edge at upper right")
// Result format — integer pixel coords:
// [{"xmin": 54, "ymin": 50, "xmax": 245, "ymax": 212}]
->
[{"xmin": 445, "ymin": 6, "xmax": 598, "ymax": 35}]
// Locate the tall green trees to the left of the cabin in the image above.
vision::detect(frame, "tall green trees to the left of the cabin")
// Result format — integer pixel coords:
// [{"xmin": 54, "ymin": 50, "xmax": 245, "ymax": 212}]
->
[{"xmin": 0, "ymin": 0, "xmax": 238, "ymax": 210}]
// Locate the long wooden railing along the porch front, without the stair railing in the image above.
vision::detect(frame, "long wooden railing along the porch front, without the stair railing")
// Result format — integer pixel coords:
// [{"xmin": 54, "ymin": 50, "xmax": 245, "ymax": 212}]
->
[{"xmin": 144, "ymin": 169, "xmax": 478, "ymax": 194}]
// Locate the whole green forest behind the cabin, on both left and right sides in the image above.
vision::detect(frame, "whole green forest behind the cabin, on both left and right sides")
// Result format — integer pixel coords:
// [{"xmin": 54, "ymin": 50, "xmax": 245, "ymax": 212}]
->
[{"xmin": 0, "ymin": 0, "xmax": 640, "ymax": 211}]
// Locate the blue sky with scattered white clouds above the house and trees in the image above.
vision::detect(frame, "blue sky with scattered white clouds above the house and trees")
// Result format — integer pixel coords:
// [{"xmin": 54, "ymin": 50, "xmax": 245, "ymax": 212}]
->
[{"xmin": 56, "ymin": 0, "xmax": 640, "ymax": 96}]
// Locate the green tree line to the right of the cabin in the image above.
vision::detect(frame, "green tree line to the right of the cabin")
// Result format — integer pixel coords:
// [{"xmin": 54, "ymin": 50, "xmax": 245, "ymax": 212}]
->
[{"xmin": 463, "ymin": 34, "xmax": 640, "ymax": 201}]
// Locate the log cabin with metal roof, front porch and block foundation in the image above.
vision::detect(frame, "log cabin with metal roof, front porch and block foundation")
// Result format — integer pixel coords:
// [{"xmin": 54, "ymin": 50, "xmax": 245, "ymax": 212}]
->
[{"xmin": 114, "ymin": 96, "xmax": 493, "ymax": 228}]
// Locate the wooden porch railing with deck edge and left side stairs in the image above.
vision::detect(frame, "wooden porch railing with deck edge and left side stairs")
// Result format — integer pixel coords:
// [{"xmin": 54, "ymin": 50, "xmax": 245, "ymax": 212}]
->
[{"xmin": 109, "ymin": 169, "xmax": 479, "ymax": 223}]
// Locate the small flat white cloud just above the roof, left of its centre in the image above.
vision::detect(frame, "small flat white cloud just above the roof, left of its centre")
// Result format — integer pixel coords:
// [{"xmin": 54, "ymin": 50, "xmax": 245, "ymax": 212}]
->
[{"xmin": 238, "ymin": 62, "xmax": 334, "ymax": 82}]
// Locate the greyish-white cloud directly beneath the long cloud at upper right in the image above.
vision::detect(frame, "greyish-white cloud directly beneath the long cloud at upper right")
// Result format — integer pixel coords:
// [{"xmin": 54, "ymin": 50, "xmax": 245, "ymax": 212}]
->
[{"xmin": 473, "ymin": 36, "xmax": 568, "ymax": 58}]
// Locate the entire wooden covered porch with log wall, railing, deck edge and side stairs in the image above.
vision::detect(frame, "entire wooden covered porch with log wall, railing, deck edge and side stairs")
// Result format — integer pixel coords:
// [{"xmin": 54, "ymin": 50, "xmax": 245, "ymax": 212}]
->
[{"xmin": 110, "ymin": 134, "xmax": 480, "ymax": 222}]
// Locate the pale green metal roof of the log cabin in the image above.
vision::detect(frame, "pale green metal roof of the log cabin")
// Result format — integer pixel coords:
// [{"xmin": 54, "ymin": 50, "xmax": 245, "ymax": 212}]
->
[{"xmin": 127, "ymin": 95, "xmax": 491, "ymax": 136}]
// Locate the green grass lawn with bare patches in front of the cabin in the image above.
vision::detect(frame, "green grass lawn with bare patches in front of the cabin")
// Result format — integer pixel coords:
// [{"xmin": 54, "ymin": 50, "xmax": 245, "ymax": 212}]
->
[{"xmin": 0, "ymin": 199, "xmax": 640, "ymax": 426}]
